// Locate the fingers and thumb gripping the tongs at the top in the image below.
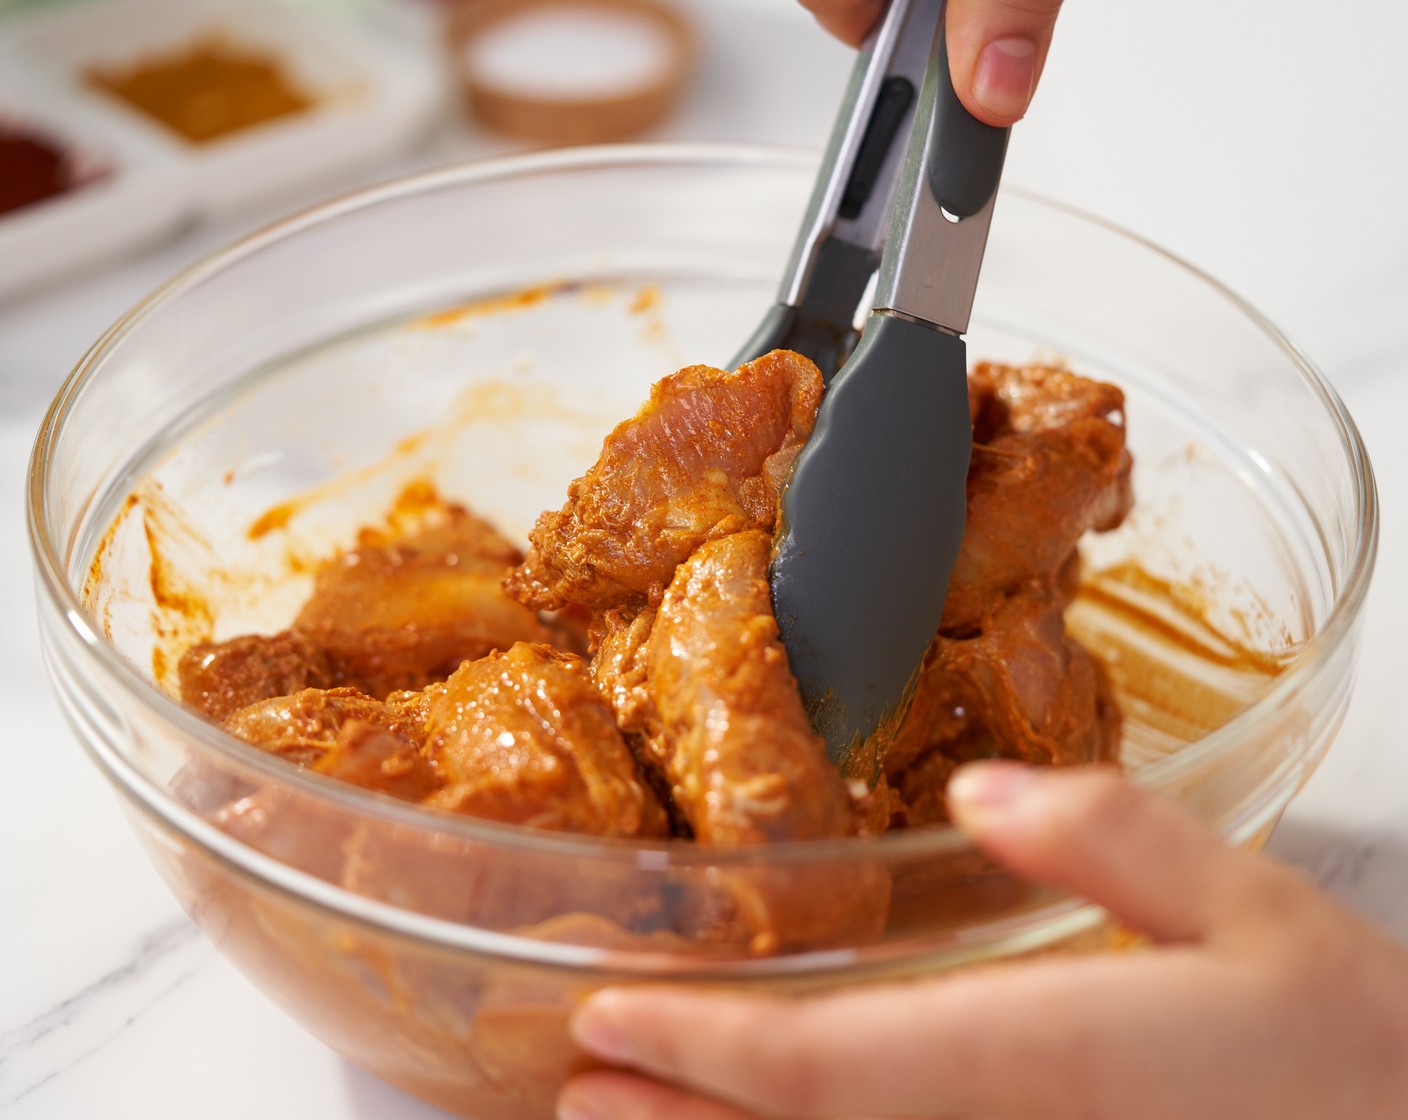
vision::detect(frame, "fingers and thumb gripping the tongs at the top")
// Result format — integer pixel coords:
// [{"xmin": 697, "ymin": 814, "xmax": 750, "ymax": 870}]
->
[{"xmin": 801, "ymin": 0, "xmax": 1060, "ymax": 127}]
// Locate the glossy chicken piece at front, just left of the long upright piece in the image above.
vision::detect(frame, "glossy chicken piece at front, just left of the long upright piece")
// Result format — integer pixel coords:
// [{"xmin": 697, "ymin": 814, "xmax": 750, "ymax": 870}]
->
[{"xmin": 414, "ymin": 642, "xmax": 666, "ymax": 837}]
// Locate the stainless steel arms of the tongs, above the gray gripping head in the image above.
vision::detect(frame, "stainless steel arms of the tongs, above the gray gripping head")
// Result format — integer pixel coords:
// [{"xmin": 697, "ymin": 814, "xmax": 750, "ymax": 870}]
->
[{"xmin": 732, "ymin": 0, "xmax": 1007, "ymax": 383}]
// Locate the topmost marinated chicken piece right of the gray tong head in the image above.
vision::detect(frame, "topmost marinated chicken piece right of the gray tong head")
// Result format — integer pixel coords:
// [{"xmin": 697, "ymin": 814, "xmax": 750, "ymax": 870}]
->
[{"xmin": 939, "ymin": 363, "xmax": 1133, "ymax": 635}]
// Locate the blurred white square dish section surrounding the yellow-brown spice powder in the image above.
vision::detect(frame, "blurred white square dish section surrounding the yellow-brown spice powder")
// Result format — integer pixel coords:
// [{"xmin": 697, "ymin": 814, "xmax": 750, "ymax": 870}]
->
[{"xmin": 0, "ymin": 0, "xmax": 444, "ymax": 214}]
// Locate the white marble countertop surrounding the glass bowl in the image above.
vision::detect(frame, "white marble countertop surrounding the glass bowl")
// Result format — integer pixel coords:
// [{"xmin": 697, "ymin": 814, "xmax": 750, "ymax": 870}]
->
[{"xmin": 0, "ymin": 0, "xmax": 1408, "ymax": 1120}]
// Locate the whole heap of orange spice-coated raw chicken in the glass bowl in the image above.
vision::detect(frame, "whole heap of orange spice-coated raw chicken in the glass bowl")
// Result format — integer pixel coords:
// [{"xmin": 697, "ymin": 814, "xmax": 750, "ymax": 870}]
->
[{"xmin": 180, "ymin": 351, "xmax": 1132, "ymax": 952}]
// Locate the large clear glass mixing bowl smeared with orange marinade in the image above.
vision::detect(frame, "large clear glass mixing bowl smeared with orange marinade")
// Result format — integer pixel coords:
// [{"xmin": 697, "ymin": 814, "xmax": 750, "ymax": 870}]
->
[{"xmin": 30, "ymin": 147, "xmax": 1377, "ymax": 1120}]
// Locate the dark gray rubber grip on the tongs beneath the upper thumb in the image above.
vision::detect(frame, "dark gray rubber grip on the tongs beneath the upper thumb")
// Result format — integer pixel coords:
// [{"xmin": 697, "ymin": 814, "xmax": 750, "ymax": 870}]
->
[{"xmin": 925, "ymin": 12, "xmax": 1011, "ymax": 218}]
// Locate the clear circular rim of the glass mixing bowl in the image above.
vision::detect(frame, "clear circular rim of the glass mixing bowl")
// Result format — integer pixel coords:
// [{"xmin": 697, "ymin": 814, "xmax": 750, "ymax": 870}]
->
[{"xmin": 27, "ymin": 144, "xmax": 1378, "ymax": 873}]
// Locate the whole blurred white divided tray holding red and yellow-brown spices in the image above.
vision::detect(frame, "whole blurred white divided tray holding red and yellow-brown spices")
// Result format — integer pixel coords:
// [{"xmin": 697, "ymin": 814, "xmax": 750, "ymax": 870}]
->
[{"xmin": 0, "ymin": 0, "xmax": 445, "ymax": 299}]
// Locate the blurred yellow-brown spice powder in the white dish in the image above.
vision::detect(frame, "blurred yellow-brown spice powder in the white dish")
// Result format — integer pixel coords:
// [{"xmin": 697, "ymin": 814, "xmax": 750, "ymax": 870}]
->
[{"xmin": 84, "ymin": 37, "xmax": 315, "ymax": 144}]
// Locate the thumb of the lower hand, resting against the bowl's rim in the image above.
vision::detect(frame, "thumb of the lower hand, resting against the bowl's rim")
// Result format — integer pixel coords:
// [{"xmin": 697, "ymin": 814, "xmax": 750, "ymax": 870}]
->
[{"xmin": 946, "ymin": 762, "xmax": 1286, "ymax": 941}]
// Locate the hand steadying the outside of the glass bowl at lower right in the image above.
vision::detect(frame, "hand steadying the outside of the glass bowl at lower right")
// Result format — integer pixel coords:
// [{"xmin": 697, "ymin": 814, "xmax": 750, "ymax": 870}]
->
[{"xmin": 559, "ymin": 762, "xmax": 1408, "ymax": 1120}]
